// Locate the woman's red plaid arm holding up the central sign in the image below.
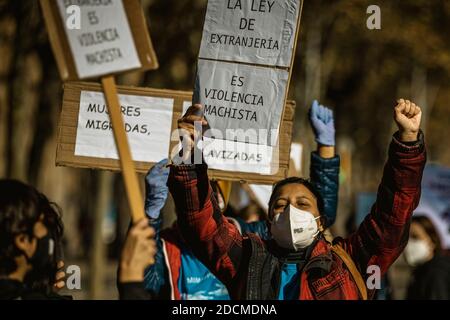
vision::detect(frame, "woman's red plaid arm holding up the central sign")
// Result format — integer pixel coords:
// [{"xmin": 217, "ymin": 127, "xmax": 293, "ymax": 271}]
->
[{"xmin": 168, "ymin": 105, "xmax": 243, "ymax": 284}]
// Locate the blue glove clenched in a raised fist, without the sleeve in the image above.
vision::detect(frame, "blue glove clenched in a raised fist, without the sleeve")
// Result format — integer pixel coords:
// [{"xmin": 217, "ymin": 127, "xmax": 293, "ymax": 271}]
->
[{"xmin": 309, "ymin": 100, "xmax": 336, "ymax": 146}]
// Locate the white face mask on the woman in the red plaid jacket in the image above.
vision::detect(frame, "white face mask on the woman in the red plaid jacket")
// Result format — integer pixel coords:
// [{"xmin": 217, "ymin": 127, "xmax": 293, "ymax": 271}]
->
[{"xmin": 270, "ymin": 205, "xmax": 319, "ymax": 250}]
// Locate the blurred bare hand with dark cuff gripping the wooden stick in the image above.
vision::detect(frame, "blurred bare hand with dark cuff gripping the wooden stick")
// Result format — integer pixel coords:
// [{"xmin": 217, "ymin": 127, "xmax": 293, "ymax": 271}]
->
[{"xmin": 118, "ymin": 219, "xmax": 156, "ymax": 300}]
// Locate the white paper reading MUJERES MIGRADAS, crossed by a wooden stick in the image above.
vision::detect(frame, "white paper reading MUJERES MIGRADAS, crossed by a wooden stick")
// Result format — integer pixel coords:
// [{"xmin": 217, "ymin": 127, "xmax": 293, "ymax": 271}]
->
[{"xmin": 75, "ymin": 91, "xmax": 174, "ymax": 162}]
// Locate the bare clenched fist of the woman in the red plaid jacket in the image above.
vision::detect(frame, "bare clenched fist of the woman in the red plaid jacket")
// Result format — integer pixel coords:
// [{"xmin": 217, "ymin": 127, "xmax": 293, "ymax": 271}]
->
[{"xmin": 394, "ymin": 99, "xmax": 422, "ymax": 142}]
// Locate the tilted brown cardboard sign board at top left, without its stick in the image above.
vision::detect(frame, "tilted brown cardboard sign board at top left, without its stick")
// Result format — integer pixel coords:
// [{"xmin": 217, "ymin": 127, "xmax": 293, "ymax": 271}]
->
[{"xmin": 41, "ymin": 0, "xmax": 158, "ymax": 81}]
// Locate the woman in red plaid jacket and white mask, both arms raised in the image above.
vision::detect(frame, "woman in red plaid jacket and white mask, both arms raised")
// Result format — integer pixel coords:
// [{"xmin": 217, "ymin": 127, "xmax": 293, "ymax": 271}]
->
[{"xmin": 168, "ymin": 99, "xmax": 426, "ymax": 300}]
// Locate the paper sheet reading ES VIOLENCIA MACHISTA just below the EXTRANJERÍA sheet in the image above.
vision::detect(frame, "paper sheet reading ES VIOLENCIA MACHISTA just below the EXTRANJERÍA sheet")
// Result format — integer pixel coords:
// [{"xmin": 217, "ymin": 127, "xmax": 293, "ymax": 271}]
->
[{"xmin": 194, "ymin": 60, "xmax": 289, "ymax": 146}]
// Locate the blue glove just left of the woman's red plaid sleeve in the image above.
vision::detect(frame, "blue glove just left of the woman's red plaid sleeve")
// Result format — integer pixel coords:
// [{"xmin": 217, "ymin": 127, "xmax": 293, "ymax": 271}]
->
[{"xmin": 145, "ymin": 159, "xmax": 169, "ymax": 219}]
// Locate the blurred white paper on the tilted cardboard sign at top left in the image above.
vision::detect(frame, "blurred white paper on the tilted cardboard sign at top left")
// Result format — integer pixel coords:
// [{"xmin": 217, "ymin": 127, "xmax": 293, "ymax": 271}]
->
[{"xmin": 57, "ymin": 0, "xmax": 141, "ymax": 79}]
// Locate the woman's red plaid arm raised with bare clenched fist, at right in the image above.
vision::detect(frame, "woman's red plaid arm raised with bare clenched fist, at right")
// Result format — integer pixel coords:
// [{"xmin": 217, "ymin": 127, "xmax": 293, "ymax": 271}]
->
[{"xmin": 337, "ymin": 100, "xmax": 426, "ymax": 277}]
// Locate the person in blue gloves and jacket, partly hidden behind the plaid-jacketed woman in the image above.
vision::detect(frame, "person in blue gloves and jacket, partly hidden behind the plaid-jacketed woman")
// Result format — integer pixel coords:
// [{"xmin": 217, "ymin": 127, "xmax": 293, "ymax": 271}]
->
[{"xmin": 144, "ymin": 101, "xmax": 340, "ymax": 300}]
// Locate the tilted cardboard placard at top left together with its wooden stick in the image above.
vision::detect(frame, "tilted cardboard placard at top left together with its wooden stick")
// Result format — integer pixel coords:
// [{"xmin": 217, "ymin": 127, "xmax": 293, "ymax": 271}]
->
[{"xmin": 40, "ymin": 0, "xmax": 158, "ymax": 222}]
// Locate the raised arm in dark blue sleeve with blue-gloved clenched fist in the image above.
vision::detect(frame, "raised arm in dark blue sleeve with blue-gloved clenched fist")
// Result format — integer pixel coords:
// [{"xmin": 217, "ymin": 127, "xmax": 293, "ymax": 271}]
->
[{"xmin": 309, "ymin": 101, "xmax": 340, "ymax": 227}]
